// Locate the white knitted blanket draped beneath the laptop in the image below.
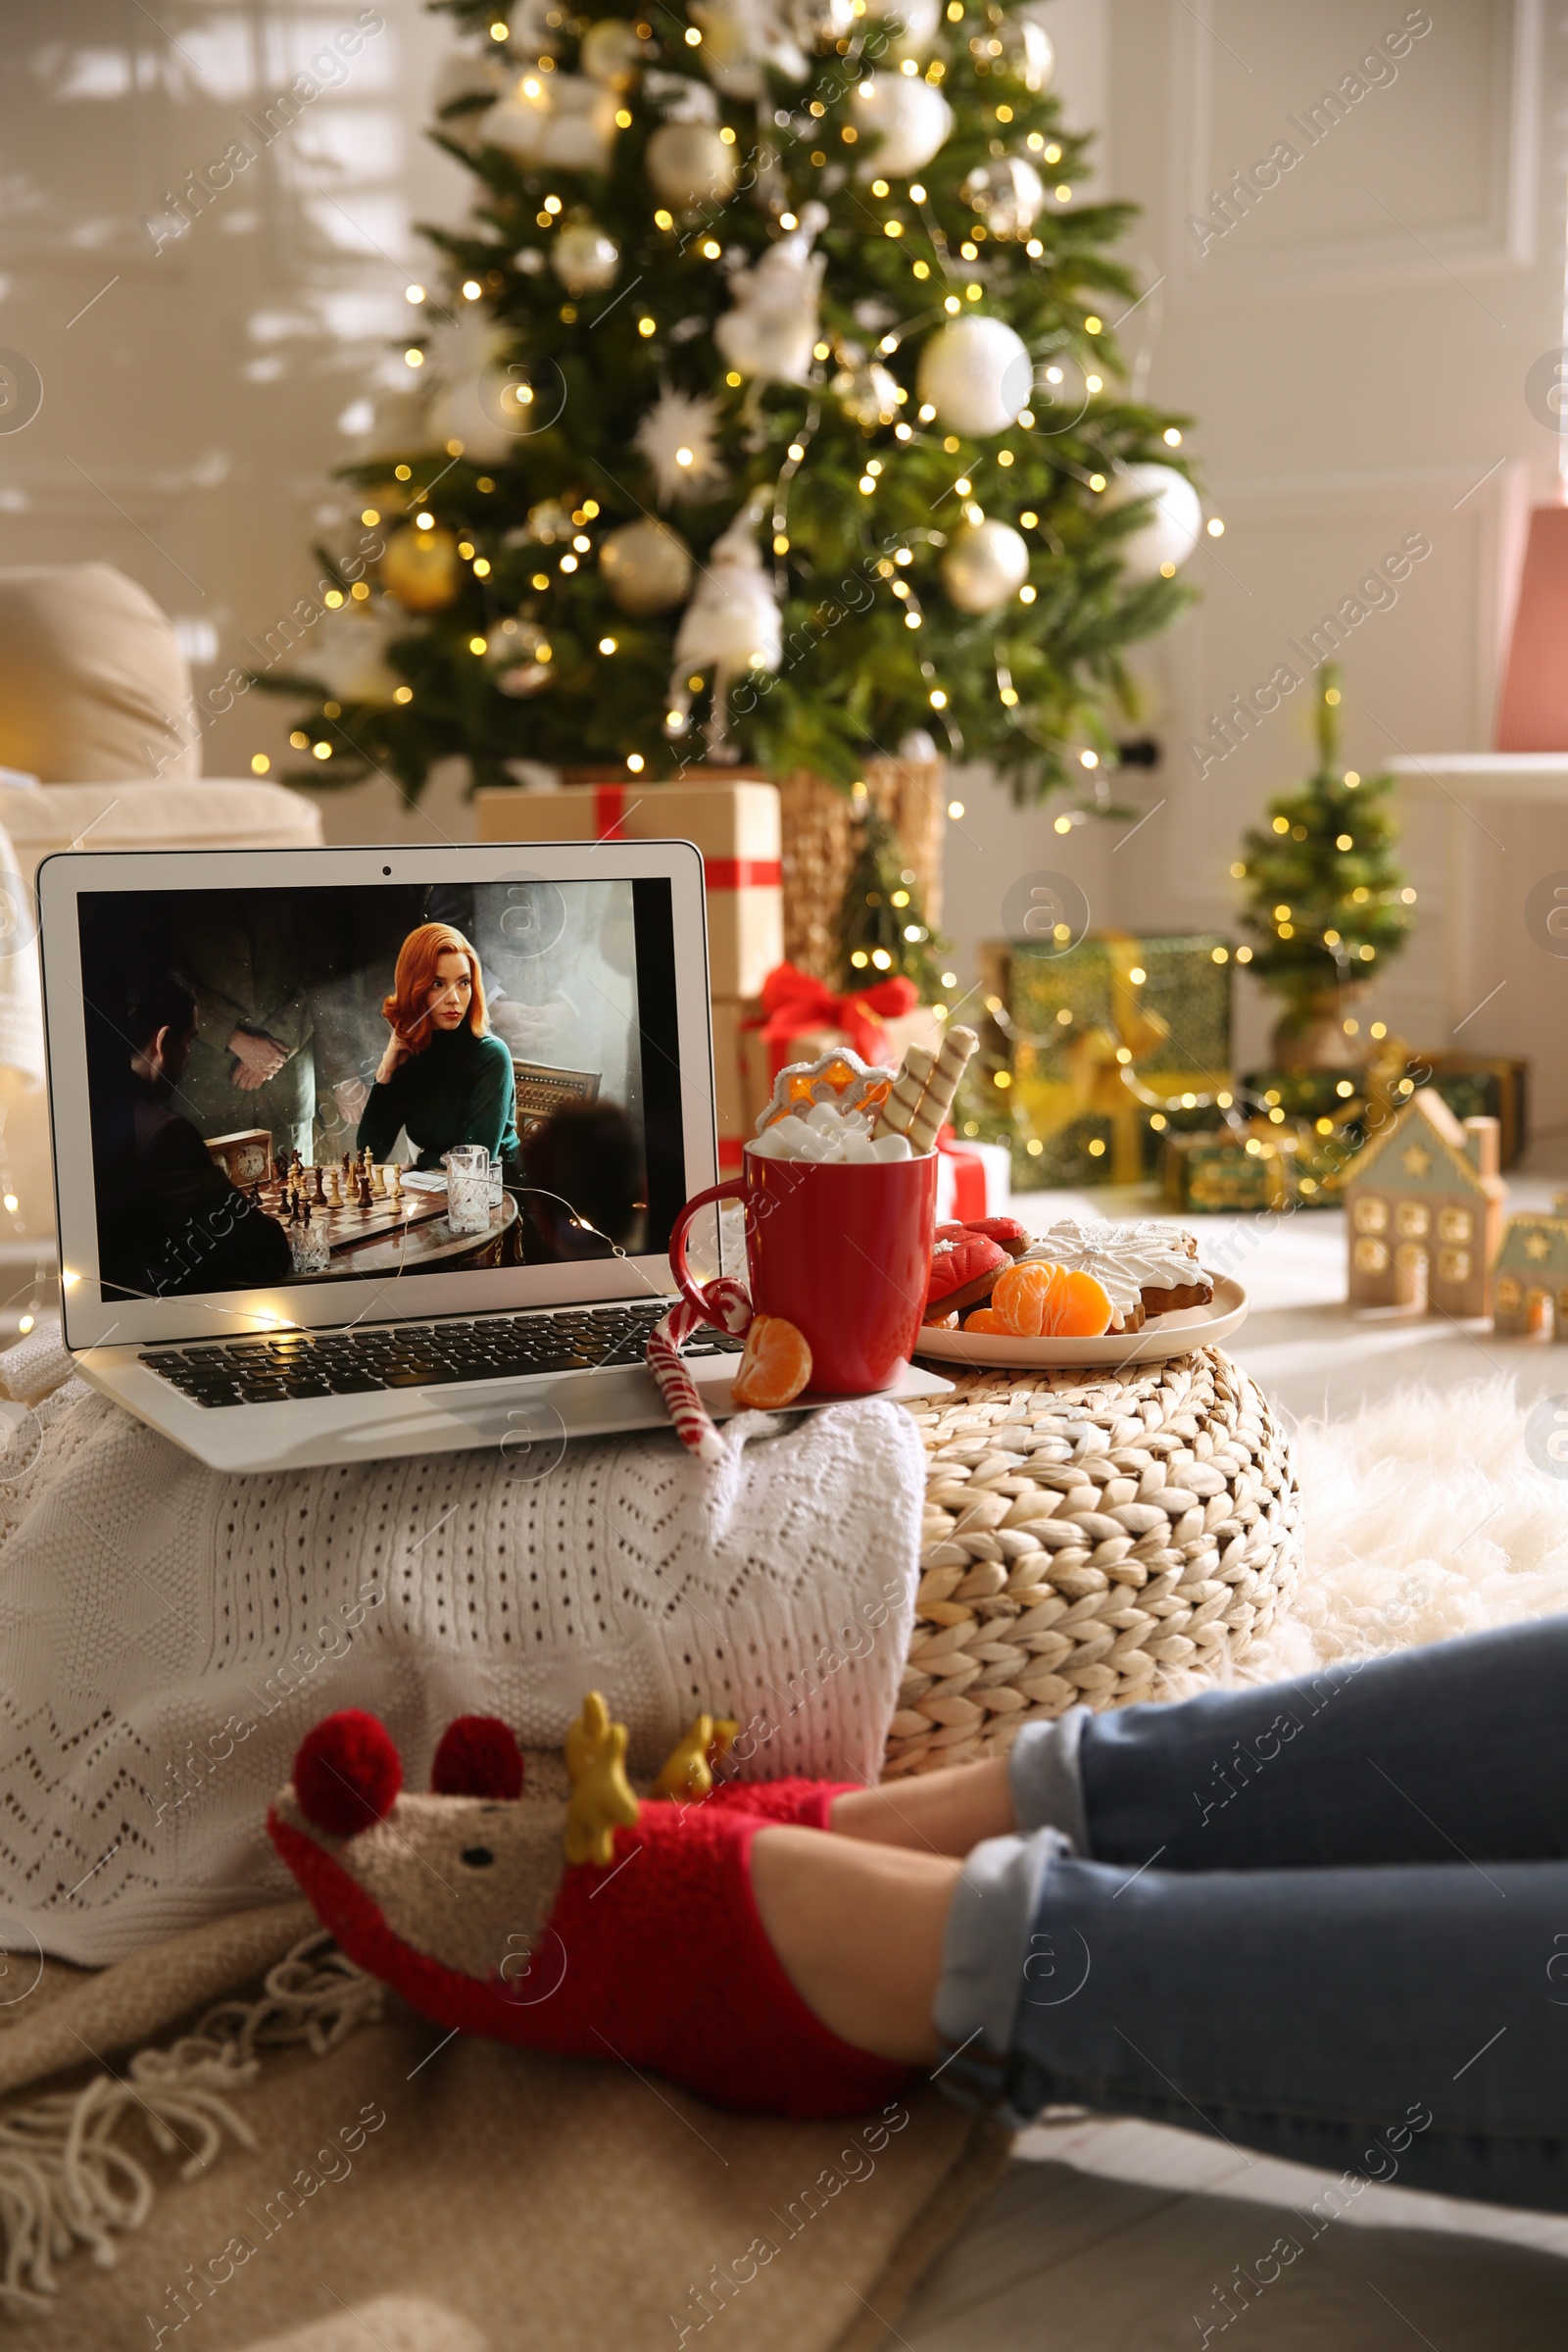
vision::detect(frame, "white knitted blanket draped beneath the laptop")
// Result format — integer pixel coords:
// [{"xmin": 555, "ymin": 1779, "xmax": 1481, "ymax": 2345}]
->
[{"xmin": 0, "ymin": 1334, "xmax": 924, "ymax": 1964}]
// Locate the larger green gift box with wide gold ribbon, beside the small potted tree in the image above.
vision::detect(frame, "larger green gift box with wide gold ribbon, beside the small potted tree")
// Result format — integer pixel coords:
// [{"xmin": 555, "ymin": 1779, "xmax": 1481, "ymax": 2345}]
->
[{"xmin": 983, "ymin": 931, "xmax": 1234, "ymax": 1186}]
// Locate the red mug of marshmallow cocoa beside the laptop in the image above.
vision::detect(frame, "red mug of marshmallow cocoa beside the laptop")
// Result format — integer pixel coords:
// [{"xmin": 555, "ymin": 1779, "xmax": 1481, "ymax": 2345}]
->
[{"xmin": 670, "ymin": 1148, "xmax": 938, "ymax": 1397}]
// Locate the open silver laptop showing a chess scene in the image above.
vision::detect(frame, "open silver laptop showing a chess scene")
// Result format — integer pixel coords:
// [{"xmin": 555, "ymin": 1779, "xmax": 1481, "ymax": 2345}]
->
[{"xmin": 37, "ymin": 842, "xmax": 950, "ymax": 1477}]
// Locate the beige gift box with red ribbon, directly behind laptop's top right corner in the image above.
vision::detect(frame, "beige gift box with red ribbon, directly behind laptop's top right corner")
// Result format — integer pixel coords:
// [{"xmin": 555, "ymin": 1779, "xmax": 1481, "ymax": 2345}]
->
[{"xmin": 475, "ymin": 776, "xmax": 783, "ymax": 1002}]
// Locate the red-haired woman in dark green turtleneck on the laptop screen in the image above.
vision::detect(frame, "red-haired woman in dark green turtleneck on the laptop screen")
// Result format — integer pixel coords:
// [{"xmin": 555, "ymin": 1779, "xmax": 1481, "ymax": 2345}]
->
[{"xmin": 355, "ymin": 922, "xmax": 517, "ymax": 1169}]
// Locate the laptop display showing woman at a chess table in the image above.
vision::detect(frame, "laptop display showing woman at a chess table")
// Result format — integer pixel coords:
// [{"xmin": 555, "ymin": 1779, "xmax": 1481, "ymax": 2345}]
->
[{"xmin": 75, "ymin": 877, "xmax": 686, "ymax": 1303}]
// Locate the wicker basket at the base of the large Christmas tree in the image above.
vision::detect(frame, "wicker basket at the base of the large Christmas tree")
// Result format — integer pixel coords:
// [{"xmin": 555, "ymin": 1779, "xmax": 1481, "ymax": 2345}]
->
[{"xmin": 778, "ymin": 755, "xmax": 948, "ymax": 978}]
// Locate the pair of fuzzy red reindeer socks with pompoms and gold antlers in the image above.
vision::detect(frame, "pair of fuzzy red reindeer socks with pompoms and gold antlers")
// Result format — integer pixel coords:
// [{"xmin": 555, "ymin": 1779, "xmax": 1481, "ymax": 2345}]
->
[{"xmin": 268, "ymin": 1693, "xmax": 909, "ymax": 2119}]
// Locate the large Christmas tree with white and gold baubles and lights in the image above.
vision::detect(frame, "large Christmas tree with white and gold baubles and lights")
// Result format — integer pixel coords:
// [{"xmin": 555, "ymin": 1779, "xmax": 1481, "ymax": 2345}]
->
[{"xmin": 270, "ymin": 0, "xmax": 1199, "ymax": 798}]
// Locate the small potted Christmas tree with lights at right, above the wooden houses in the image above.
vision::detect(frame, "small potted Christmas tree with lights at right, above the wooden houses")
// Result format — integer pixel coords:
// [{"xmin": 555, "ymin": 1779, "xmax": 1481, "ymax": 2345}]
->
[{"xmin": 1232, "ymin": 663, "xmax": 1415, "ymax": 1068}]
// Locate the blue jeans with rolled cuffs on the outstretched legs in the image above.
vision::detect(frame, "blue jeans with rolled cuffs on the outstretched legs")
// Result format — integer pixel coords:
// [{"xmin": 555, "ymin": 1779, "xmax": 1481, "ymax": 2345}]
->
[{"xmin": 936, "ymin": 1618, "xmax": 1568, "ymax": 2211}]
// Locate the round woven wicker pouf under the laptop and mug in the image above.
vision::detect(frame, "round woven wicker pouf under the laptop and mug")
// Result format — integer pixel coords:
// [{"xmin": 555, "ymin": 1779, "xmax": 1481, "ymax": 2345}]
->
[{"xmin": 884, "ymin": 1348, "xmax": 1300, "ymax": 1778}]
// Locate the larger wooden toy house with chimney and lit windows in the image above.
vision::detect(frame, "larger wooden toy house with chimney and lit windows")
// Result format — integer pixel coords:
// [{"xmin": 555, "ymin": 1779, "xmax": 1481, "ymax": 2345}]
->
[{"xmin": 1343, "ymin": 1087, "xmax": 1507, "ymax": 1322}]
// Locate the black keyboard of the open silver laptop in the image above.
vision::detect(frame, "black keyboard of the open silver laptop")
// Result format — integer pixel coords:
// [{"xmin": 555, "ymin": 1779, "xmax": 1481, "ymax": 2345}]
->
[{"xmin": 141, "ymin": 1298, "xmax": 745, "ymax": 1406}]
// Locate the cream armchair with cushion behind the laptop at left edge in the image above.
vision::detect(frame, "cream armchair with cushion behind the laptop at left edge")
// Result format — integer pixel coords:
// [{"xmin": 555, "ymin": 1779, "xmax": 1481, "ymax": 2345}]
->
[{"xmin": 0, "ymin": 564, "xmax": 322, "ymax": 1260}]
